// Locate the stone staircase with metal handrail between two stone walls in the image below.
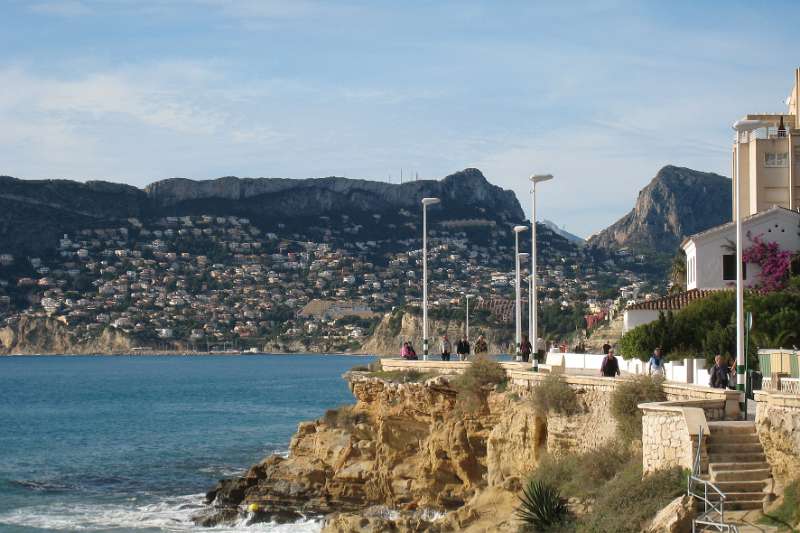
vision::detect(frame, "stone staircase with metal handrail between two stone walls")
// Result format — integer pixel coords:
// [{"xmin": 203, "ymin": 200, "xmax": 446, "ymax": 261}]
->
[{"xmin": 706, "ymin": 422, "xmax": 772, "ymax": 511}]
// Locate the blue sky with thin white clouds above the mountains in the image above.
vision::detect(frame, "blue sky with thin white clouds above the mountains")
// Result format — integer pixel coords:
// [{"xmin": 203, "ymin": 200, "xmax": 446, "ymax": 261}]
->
[{"xmin": 0, "ymin": 0, "xmax": 800, "ymax": 237}]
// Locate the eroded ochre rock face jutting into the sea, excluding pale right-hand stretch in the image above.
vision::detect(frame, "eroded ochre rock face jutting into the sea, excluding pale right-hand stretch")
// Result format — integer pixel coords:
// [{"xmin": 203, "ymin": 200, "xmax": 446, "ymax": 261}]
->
[{"xmin": 197, "ymin": 373, "xmax": 541, "ymax": 531}]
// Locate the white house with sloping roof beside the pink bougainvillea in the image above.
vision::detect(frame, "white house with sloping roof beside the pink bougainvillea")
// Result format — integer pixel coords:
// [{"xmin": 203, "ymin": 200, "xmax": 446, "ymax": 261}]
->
[{"xmin": 681, "ymin": 206, "xmax": 800, "ymax": 289}]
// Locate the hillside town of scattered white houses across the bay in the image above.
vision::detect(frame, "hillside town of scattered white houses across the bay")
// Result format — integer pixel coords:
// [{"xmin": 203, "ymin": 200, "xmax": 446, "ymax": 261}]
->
[{"xmin": 0, "ymin": 213, "xmax": 659, "ymax": 352}]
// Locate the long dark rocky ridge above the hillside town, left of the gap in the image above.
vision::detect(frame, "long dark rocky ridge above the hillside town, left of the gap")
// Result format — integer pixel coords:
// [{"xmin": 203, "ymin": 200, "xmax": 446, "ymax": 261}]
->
[{"xmin": 0, "ymin": 168, "xmax": 524, "ymax": 255}]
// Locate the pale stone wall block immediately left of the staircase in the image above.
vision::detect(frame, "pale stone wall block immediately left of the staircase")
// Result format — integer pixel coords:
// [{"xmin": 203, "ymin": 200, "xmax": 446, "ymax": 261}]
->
[{"xmin": 639, "ymin": 400, "xmax": 715, "ymax": 473}]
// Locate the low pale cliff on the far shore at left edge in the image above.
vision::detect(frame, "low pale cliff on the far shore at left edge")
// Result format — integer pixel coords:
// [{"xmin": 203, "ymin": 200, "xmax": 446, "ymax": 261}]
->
[{"xmin": 0, "ymin": 316, "xmax": 133, "ymax": 354}]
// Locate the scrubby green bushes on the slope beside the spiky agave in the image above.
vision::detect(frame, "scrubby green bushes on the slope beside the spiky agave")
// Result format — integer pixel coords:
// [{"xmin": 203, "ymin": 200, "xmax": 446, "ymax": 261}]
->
[{"xmin": 532, "ymin": 444, "xmax": 686, "ymax": 533}]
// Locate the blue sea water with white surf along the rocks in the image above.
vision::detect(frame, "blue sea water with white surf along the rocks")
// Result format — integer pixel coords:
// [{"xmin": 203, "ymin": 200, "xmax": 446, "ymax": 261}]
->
[{"xmin": 0, "ymin": 355, "xmax": 370, "ymax": 533}]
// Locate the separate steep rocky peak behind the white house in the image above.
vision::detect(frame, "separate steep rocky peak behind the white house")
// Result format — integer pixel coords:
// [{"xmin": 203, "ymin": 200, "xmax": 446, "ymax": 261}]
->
[{"xmin": 588, "ymin": 165, "xmax": 732, "ymax": 254}]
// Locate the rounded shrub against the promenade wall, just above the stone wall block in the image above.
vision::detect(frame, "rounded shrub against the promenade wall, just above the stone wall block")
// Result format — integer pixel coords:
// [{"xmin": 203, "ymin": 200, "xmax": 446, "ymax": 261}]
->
[{"xmin": 611, "ymin": 376, "xmax": 666, "ymax": 442}]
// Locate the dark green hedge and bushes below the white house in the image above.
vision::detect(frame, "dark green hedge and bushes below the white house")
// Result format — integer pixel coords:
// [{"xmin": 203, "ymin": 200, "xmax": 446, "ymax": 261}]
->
[{"xmin": 620, "ymin": 282, "xmax": 800, "ymax": 368}]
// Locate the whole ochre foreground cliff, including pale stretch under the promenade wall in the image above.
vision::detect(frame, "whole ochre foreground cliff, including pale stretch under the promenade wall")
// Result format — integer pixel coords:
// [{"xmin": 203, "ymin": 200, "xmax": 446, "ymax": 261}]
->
[{"xmin": 196, "ymin": 372, "xmax": 615, "ymax": 533}]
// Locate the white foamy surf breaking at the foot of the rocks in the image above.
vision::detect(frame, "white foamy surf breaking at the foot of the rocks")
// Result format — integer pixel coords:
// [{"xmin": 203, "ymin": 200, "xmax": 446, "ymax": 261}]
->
[{"xmin": 0, "ymin": 494, "xmax": 322, "ymax": 533}]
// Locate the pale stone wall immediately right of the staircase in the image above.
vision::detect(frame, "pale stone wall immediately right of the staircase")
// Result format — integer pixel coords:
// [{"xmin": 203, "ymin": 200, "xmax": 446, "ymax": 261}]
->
[{"xmin": 754, "ymin": 391, "xmax": 800, "ymax": 484}]
